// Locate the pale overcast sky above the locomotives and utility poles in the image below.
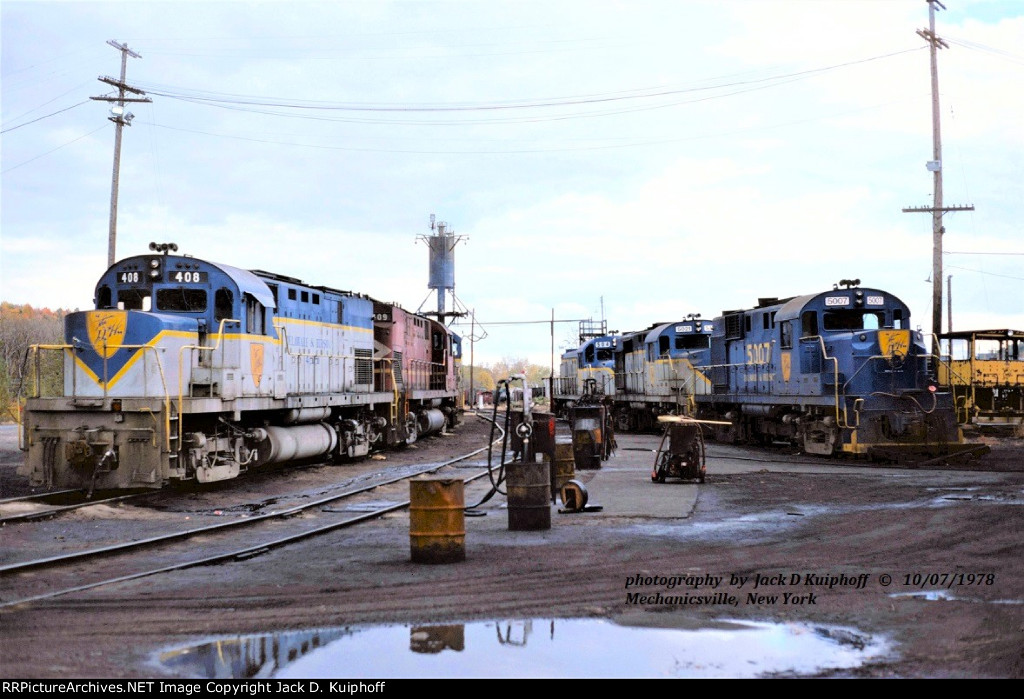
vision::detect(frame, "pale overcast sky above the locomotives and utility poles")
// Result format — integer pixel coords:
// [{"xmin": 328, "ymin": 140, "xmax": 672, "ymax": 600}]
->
[{"xmin": 0, "ymin": 0, "xmax": 1024, "ymax": 372}]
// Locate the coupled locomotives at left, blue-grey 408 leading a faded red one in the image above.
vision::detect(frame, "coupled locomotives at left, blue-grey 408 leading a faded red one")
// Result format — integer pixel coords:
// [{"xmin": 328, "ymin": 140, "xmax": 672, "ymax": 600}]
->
[{"xmin": 19, "ymin": 244, "xmax": 461, "ymax": 490}]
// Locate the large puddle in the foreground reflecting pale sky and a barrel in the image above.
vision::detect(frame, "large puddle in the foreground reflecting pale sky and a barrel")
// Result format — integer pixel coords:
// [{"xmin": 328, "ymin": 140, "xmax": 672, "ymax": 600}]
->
[{"xmin": 158, "ymin": 619, "xmax": 891, "ymax": 680}]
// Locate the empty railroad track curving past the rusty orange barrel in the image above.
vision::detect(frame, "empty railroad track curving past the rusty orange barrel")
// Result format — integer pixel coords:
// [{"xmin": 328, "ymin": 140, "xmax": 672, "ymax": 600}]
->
[{"xmin": 0, "ymin": 417, "xmax": 512, "ymax": 611}]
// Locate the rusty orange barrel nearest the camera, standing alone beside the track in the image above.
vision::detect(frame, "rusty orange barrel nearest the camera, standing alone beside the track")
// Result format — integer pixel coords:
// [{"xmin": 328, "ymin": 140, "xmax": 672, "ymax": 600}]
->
[{"xmin": 409, "ymin": 477, "xmax": 466, "ymax": 563}]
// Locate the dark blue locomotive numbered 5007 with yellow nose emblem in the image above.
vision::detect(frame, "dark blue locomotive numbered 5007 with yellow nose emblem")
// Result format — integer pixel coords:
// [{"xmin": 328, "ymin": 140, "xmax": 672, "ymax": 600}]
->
[{"xmin": 695, "ymin": 279, "xmax": 964, "ymax": 461}]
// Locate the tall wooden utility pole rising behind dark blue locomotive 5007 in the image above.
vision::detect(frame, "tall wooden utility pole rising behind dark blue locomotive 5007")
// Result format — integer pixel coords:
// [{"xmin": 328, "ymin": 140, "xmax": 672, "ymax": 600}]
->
[{"xmin": 903, "ymin": 0, "xmax": 974, "ymax": 347}]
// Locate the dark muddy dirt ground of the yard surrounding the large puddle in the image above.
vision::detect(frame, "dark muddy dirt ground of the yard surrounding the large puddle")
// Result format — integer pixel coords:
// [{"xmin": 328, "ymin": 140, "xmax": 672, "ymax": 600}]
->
[{"xmin": 0, "ymin": 420, "xmax": 1024, "ymax": 679}]
